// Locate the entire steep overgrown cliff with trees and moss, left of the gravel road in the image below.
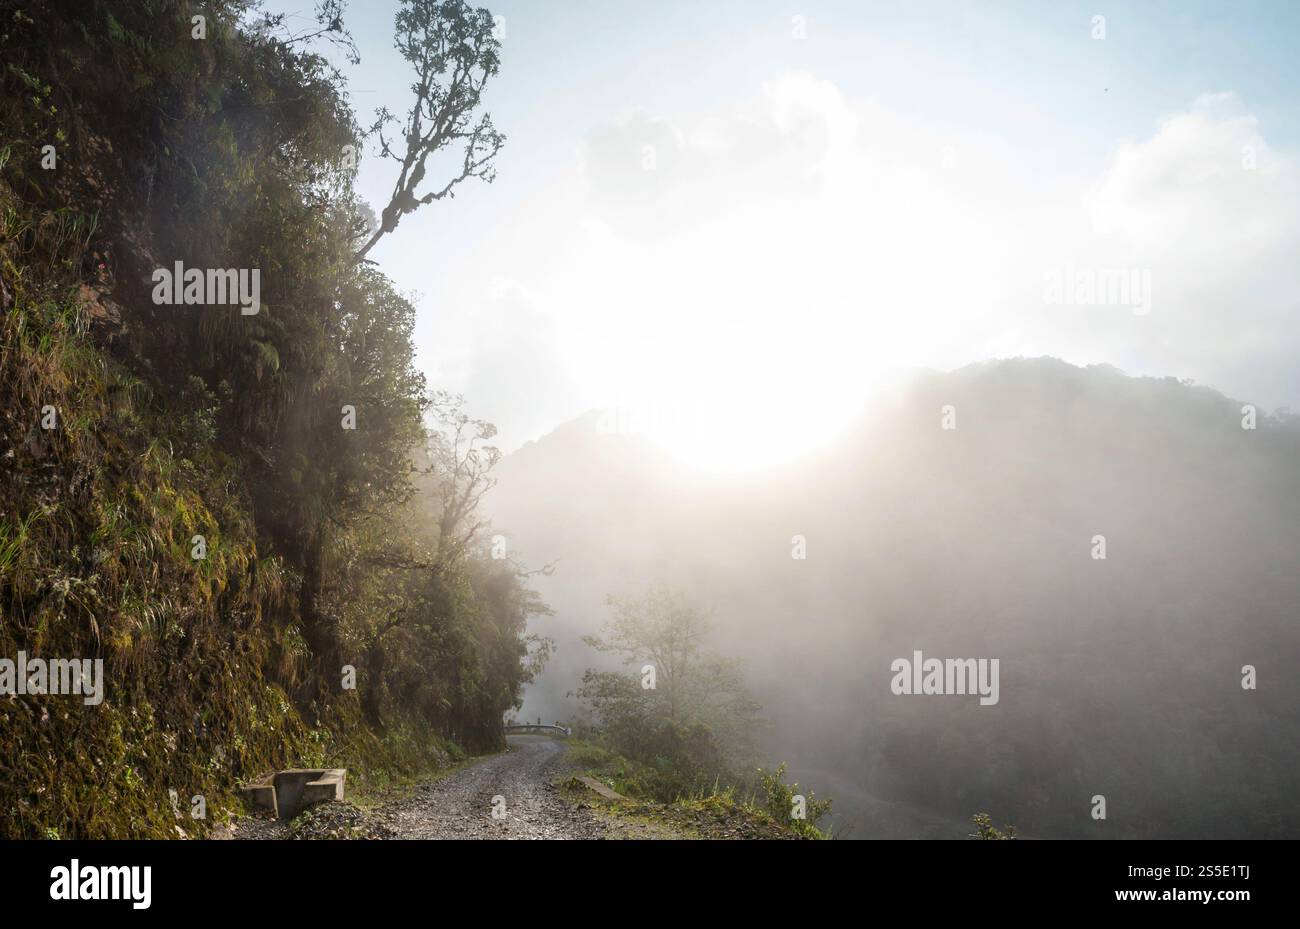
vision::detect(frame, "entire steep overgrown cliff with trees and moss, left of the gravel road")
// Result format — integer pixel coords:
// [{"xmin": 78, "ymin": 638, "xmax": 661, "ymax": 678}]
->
[{"xmin": 0, "ymin": 0, "xmax": 537, "ymax": 837}]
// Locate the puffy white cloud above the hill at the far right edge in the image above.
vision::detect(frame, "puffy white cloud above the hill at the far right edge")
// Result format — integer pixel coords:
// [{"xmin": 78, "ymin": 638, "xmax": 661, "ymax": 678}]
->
[{"xmin": 1087, "ymin": 94, "xmax": 1300, "ymax": 405}]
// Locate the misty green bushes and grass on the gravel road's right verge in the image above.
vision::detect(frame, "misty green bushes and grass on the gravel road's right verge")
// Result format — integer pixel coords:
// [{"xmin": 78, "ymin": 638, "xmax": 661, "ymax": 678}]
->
[{"xmin": 569, "ymin": 586, "xmax": 831, "ymax": 838}]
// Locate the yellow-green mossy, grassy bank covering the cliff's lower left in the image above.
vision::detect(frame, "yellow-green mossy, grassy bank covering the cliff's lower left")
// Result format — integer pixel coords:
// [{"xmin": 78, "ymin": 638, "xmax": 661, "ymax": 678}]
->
[{"xmin": 0, "ymin": 172, "xmax": 320, "ymax": 835}]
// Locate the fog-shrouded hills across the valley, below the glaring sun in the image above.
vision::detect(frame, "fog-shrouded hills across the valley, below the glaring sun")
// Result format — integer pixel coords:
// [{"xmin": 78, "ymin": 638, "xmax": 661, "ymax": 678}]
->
[{"xmin": 490, "ymin": 359, "xmax": 1300, "ymax": 838}]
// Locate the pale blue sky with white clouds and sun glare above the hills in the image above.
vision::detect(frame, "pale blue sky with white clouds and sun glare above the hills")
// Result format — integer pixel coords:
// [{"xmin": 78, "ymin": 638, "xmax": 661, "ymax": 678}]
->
[{"xmin": 269, "ymin": 0, "xmax": 1300, "ymax": 469}]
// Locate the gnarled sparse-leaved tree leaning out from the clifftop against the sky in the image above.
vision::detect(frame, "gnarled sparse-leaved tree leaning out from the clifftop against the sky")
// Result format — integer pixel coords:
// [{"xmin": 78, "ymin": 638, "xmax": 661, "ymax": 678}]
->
[{"xmin": 356, "ymin": 0, "xmax": 506, "ymax": 260}]
